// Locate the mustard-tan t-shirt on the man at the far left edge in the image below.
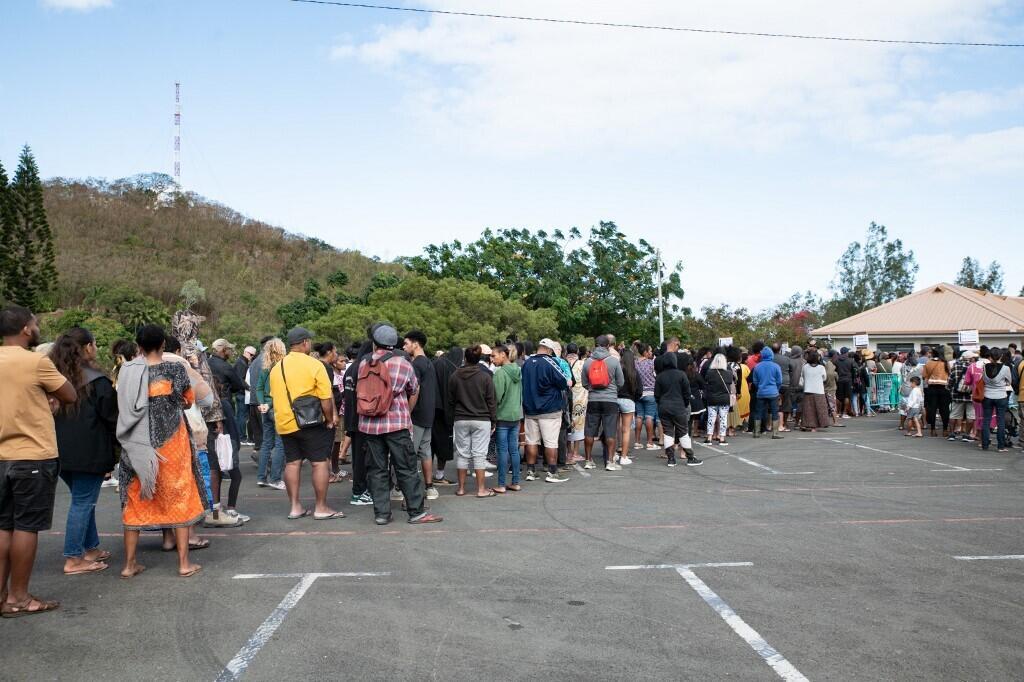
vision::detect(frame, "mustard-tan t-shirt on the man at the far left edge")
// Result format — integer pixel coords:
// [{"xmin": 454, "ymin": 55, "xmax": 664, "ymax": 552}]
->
[{"xmin": 0, "ymin": 346, "xmax": 68, "ymax": 461}]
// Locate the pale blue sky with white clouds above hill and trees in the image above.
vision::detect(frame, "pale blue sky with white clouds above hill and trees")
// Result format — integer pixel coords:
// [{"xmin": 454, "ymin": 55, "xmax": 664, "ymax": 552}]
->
[{"xmin": 0, "ymin": 0, "xmax": 1024, "ymax": 309}]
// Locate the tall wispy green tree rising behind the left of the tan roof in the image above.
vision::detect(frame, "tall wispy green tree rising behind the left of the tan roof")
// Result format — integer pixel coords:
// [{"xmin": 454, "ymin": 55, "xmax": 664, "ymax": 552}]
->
[{"xmin": 823, "ymin": 222, "xmax": 918, "ymax": 323}]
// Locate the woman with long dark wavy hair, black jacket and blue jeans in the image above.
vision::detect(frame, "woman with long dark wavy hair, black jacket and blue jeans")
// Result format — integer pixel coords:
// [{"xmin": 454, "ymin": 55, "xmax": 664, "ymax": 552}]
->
[{"xmin": 50, "ymin": 327, "xmax": 118, "ymax": 576}]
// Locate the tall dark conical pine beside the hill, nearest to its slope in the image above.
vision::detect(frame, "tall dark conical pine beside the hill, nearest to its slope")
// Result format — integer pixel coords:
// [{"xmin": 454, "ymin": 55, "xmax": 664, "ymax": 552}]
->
[{"xmin": 6, "ymin": 145, "xmax": 57, "ymax": 311}]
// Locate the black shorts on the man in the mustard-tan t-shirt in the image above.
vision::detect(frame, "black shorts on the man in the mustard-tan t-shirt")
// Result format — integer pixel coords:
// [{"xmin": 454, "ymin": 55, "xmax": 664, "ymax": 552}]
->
[{"xmin": 0, "ymin": 459, "xmax": 60, "ymax": 532}]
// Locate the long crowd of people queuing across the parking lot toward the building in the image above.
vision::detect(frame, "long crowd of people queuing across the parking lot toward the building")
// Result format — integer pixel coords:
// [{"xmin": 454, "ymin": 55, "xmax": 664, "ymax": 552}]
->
[{"xmin": 0, "ymin": 306, "xmax": 1022, "ymax": 617}]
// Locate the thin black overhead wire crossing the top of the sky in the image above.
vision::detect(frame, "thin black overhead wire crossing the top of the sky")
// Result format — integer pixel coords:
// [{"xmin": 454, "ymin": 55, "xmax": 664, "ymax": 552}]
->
[{"xmin": 290, "ymin": 0, "xmax": 1024, "ymax": 47}]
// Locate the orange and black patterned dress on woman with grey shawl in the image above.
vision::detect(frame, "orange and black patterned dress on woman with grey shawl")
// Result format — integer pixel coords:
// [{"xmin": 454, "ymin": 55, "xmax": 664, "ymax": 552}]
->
[{"xmin": 120, "ymin": 363, "xmax": 206, "ymax": 530}]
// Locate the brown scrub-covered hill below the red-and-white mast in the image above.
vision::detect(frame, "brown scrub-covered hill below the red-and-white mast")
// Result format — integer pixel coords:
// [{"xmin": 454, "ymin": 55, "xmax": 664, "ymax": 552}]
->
[{"xmin": 45, "ymin": 175, "xmax": 402, "ymax": 339}]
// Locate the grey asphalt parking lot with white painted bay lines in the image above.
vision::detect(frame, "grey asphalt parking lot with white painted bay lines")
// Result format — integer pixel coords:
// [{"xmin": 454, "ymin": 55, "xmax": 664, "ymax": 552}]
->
[{"xmin": 0, "ymin": 417, "xmax": 1024, "ymax": 680}]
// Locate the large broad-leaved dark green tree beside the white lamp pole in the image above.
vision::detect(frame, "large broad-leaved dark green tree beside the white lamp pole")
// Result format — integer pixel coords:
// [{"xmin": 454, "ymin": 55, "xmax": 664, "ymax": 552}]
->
[{"xmin": 404, "ymin": 222, "xmax": 683, "ymax": 337}]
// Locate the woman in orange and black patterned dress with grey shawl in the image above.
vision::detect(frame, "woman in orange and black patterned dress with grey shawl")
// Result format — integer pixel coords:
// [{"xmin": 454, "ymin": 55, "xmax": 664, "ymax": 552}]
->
[{"xmin": 118, "ymin": 325, "xmax": 206, "ymax": 578}]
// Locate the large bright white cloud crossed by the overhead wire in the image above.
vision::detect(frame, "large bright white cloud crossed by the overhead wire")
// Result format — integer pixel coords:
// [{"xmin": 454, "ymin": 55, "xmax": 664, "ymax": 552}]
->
[{"xmin": 332, "ymin": 0, "xmax": 1021, "ymax": 157}]
